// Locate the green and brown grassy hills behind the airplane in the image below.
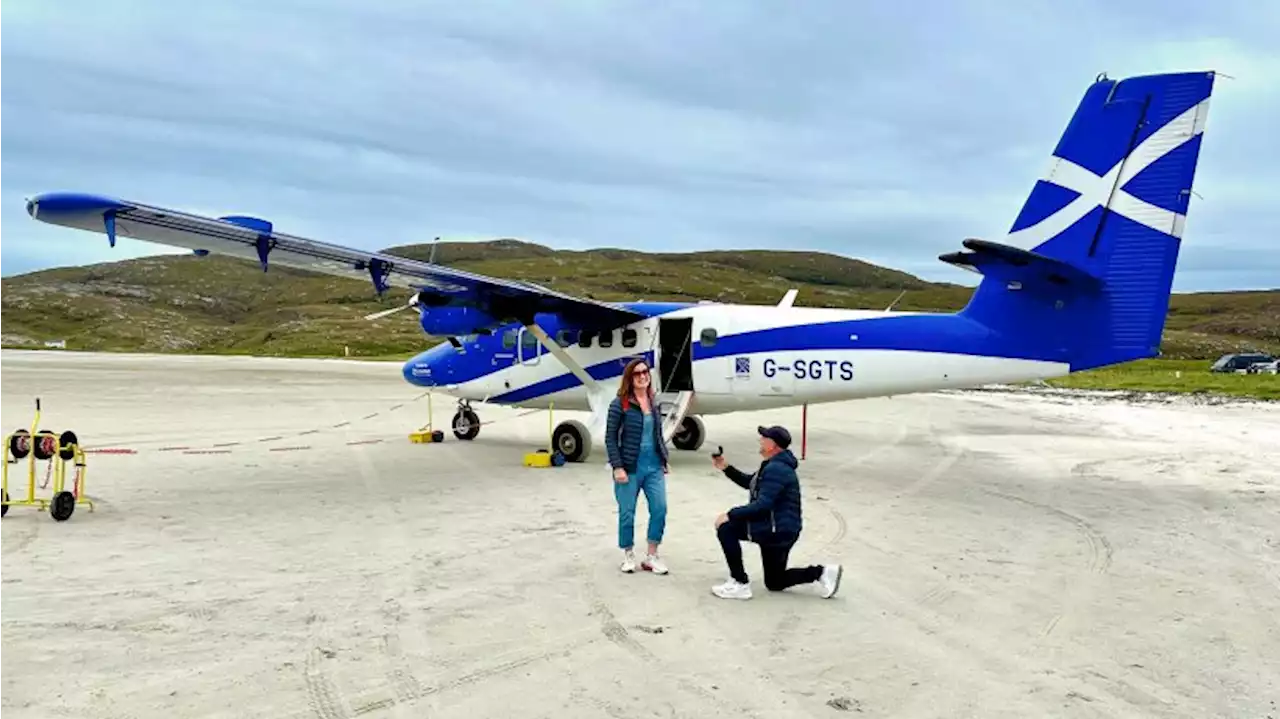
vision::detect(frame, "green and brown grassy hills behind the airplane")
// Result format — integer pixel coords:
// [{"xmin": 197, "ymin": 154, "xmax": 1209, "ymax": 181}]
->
[{"xmin": 0, "ymin": 241, "xmax": 1280, "ymax": 360}]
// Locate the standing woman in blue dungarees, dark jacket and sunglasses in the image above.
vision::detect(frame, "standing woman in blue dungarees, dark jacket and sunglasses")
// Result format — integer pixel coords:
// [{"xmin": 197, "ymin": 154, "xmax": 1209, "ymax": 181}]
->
[{"xmin": 604, "ymin": 360, "xmax": 668, "ymax": 574}]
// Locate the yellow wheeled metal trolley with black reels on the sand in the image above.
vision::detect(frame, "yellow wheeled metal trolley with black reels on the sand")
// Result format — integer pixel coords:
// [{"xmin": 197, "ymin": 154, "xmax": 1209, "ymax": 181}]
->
[{"xmin": 0, "ymin": 398, "xmax": 93, "ymax": 522}]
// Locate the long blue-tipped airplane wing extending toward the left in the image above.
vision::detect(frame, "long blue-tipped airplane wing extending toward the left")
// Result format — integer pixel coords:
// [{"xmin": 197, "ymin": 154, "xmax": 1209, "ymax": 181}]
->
[{"xmin": 27, "ymin": 192, "xmax": 644, "ymax": 326}]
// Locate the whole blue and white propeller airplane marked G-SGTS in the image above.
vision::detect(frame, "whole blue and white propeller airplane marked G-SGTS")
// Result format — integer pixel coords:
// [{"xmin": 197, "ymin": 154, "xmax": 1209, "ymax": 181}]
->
[{"xmin": 27, "ymin": 72, "xmax": 1215, "ymax": 462}]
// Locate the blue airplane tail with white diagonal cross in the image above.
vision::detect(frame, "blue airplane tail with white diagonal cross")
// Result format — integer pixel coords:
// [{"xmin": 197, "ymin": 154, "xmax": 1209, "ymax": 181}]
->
[{"xmin": 940, "ymin": 72, "xmax": 1213, "ymax": 371}]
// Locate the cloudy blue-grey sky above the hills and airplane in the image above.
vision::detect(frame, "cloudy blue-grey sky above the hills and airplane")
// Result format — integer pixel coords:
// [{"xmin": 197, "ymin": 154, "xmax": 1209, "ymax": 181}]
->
[{"xmin": 0, "ymin": 0, "xmax": 1280, "ymax": 292}]
